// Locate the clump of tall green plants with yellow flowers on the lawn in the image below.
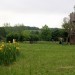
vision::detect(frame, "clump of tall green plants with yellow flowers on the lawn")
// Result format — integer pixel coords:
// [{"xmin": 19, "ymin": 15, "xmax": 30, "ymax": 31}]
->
[{"xmin": 0, "ymin": 43, "xmax": 19, "ymax": 65}]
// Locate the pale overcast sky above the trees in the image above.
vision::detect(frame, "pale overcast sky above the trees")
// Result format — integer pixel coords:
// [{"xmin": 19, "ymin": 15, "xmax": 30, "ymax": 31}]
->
[{"xmin": 0, "ymin": 0, "xmax": 75, "ymax": 28}]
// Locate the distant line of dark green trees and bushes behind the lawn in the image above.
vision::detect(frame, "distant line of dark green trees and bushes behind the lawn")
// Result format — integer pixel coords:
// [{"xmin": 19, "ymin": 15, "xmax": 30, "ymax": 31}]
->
[{"xmin": 0, "ymin": 25, "xmax": 68, "ymax": 43}]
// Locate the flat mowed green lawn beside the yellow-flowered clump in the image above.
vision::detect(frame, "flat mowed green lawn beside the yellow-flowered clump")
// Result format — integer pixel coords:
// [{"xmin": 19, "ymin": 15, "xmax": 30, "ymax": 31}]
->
[{"xmin": 0, "ymin": 43, "xmax": 75, "ymax": 75}]
